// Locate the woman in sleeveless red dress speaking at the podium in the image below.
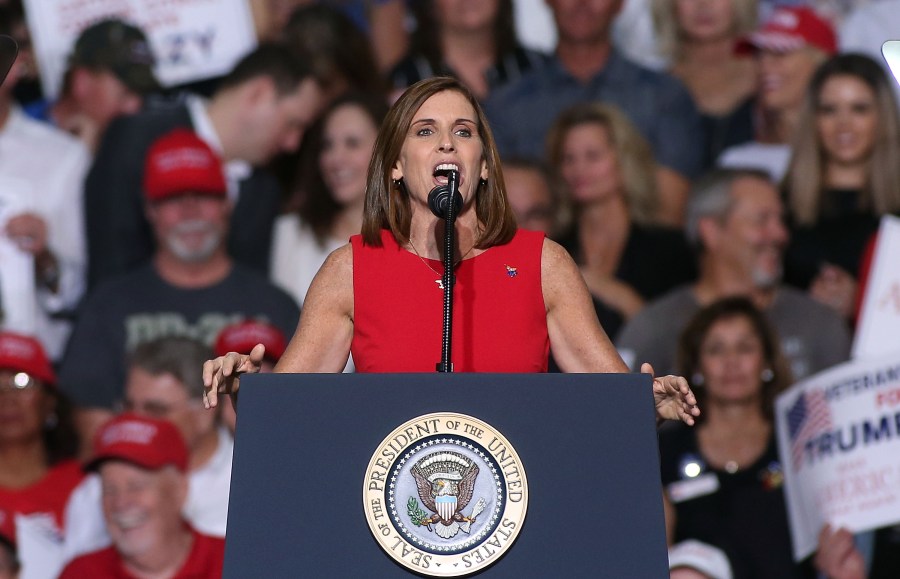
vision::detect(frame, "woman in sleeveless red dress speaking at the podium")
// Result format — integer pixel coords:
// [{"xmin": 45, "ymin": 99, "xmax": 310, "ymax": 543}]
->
[{"xmin": 203, "ymin": 77, "xmax": 699, "ymax": 424}]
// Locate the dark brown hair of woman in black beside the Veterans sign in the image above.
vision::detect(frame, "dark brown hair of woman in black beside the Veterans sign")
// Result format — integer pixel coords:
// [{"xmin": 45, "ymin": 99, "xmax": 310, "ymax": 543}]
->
[{"xmin": 678, "ymin": 297, "xmax": 793, "ymax": 423}]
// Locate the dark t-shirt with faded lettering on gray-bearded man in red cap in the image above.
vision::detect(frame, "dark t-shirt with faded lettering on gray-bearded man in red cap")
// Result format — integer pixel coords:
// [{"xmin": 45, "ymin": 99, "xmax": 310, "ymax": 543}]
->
[{"xmin": 59, "ymin": 264, "xmax": 300, "ymax": 408}]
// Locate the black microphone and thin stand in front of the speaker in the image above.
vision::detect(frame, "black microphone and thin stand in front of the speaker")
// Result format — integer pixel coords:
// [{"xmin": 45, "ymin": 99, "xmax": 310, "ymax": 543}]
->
[{"xmin": 428, "ymin": 171, "xmax": 462, "ymax": 372}]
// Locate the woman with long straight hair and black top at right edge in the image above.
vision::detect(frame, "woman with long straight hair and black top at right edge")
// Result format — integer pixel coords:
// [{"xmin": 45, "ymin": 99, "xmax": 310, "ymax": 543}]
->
[{"xmin": 784, "ymin": 54, "xmax": 900, "ymax": 318}]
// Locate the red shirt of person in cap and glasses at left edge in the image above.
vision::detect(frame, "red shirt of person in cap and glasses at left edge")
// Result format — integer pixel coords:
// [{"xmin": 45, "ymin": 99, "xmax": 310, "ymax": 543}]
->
[{"xmin": 0, "ymin": 460, "xmax": 84, "ymax": 538}]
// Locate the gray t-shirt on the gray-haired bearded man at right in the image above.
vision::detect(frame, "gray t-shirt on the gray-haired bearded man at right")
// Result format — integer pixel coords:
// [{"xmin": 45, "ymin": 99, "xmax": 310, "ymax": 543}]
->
[{"xmin": 616, "ymin": 286, "xmax": 851, "ymax": 380}]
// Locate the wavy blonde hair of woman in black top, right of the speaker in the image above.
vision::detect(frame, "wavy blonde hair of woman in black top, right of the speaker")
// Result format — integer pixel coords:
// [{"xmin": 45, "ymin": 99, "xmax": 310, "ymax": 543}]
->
[{"xmin": 547, "ymin": 102, "xmax": 659, "ymax": 225}]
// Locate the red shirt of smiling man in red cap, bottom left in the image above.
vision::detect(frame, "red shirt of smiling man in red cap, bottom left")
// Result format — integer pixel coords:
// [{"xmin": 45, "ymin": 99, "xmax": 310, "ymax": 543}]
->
[{"xmin": 59, "ymin": 530, "xmax": 225, "ymax": 579}]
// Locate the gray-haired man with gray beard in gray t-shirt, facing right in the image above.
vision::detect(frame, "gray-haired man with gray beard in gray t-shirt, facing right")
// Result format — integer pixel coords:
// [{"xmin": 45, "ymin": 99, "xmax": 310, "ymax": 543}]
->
[{"xmin": 616, "ymin": 169, "xmax": 850, "ymax": 379}]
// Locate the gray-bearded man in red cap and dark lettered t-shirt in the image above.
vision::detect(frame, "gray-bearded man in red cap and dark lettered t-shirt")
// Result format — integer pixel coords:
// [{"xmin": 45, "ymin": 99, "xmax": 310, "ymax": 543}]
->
[{"xmin": 59, "ymin": 129, "xmax": 300, "ymax": 454}]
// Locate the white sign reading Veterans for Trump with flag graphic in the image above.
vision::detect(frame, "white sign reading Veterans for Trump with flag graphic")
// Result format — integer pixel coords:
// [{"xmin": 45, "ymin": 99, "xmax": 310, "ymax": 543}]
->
[{"xmin": 775, "ymin": 354, "xmax": 900, "ymax": 560}]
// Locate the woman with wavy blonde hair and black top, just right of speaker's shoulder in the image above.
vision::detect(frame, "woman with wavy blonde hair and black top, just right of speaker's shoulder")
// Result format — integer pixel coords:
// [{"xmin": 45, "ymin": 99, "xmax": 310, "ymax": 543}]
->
[{"xmin": 547, "ymin": 103, "xmax": 695, "ymax": 335}]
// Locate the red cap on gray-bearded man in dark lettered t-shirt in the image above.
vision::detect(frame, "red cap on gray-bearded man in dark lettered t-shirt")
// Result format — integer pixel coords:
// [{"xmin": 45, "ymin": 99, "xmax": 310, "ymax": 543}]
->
[{"xmin": 144, "ymin": 129, "xmax": 227, "ymax": 201}]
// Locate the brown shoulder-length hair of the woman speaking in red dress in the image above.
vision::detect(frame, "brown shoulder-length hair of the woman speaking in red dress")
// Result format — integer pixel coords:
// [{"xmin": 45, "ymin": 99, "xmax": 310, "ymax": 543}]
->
[{"xmin": 362, "ymin": 76, "xmax": 516, "ymax": 249}]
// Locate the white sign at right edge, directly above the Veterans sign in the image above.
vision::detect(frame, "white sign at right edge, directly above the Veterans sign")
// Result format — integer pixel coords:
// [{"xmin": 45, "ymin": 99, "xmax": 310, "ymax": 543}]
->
[{"xmin": 853, "ymin": 216, "xmax": 900, "ymax": 358}]
